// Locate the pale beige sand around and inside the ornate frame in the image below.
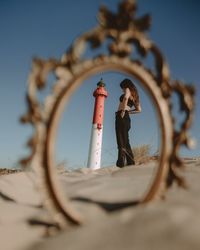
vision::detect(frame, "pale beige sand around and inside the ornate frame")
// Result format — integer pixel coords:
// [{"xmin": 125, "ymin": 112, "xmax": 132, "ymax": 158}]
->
[{"xmin": 0, "ymin": 159, "xmax": 200, "ymax": 250}]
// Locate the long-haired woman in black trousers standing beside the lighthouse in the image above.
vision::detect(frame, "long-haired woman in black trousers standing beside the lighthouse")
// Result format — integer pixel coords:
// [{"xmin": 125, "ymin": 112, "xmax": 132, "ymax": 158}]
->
[{"xmin": 115, "ymin": 79, "xmax": 141, "ymax": 168}]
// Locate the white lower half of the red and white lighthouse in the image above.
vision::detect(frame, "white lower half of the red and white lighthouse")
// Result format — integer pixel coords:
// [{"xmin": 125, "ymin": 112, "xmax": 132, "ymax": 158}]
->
[{"xmin": 87, "ymin": 124, "xmax": 103, "ymax": 169}]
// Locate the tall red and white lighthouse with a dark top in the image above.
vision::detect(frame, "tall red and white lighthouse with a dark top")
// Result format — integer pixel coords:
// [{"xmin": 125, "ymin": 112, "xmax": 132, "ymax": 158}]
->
[{"xmin": 87, "ymin": 79, "xmax": 108, "ymax": 169}]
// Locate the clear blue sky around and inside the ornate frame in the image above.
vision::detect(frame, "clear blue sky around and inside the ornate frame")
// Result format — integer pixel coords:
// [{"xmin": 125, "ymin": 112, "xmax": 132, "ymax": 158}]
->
[{"xmin": 0, "ymin": 0, "xmax": 200, "ymax": 168}]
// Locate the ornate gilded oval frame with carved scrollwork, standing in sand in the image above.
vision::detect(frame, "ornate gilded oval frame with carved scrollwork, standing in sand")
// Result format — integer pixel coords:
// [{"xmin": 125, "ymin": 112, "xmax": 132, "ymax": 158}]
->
[{"xmin": 21, "ymin": 0, "xmax": 195, "ymax": 227}]
